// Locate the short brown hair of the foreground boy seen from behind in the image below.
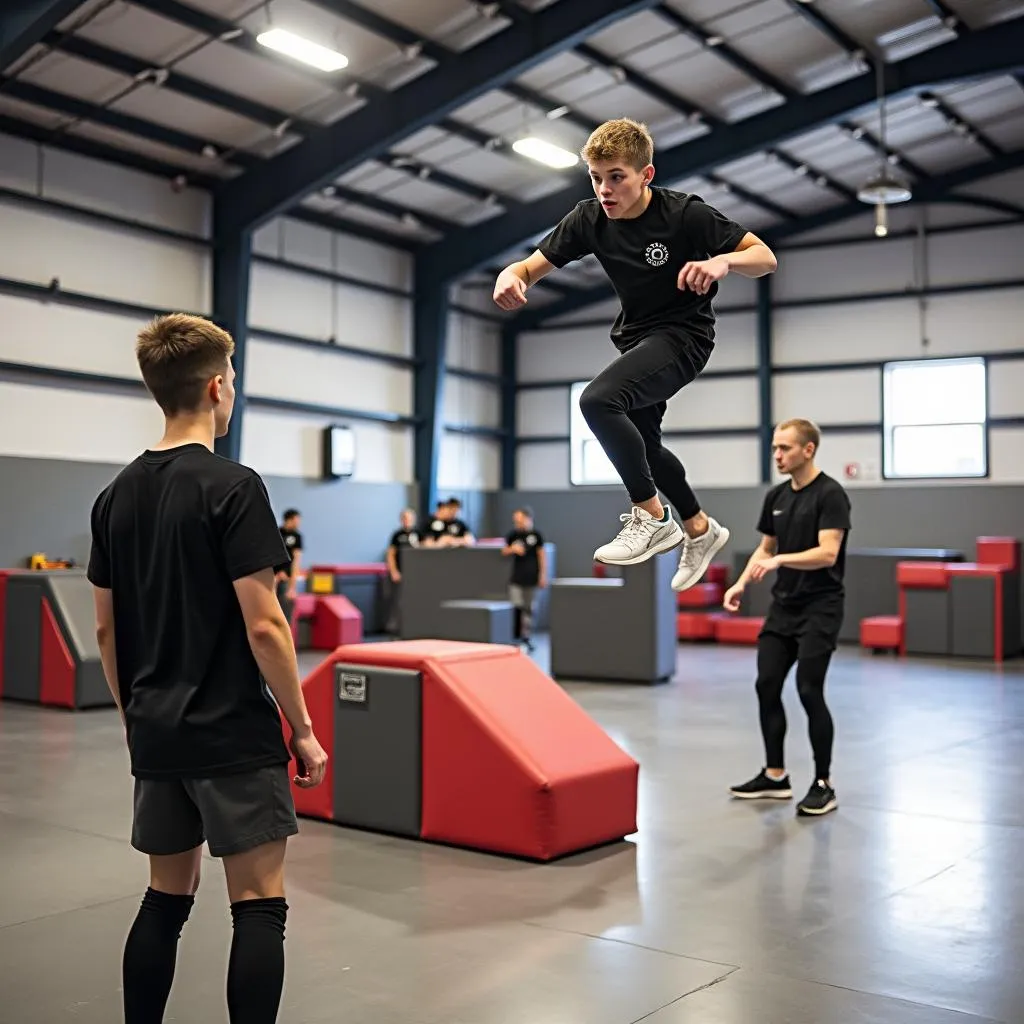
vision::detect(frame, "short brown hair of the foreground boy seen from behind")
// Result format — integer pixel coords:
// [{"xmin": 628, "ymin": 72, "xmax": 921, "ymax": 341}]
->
[{"xmin": 135, "ymin": 313, "xmax": 234, "ymax": 416}]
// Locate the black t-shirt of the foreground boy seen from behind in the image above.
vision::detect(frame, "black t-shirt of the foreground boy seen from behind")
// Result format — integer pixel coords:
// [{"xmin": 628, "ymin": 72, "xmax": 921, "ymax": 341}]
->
[{"xmin": 87, "ymin": 444, "xmax": 289, "ymax": 778}]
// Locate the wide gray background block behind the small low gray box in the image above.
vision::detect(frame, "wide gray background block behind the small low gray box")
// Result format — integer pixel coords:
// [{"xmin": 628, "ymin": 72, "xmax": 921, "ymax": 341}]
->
[{"xmin": 399, "ymin": 544, "xmax": 555, "ymax": 642}]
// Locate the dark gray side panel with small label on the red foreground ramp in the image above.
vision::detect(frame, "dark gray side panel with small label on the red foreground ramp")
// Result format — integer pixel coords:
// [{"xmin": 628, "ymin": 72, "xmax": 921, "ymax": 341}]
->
[{"xmin": 332, "ymin": 663, "xmax": 423, "ymax": 838}]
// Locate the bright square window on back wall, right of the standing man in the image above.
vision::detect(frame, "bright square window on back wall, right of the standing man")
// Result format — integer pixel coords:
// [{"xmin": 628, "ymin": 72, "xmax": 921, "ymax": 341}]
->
[{"xmin": 882, "ymin": 357, "xmax": 988, "ymax": 478}]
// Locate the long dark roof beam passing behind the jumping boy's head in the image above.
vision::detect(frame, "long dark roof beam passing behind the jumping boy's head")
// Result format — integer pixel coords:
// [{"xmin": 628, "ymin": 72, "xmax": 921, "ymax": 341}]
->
[{"xmin": 417, "ymin": 18, "xmax": 1024, "ymax": 287}]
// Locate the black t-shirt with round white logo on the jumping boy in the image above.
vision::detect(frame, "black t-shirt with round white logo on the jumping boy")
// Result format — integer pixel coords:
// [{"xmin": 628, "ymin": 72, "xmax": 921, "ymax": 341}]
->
[{"xmin": 538, "ymin": 187, "xmax": 746, "ymax": 366}]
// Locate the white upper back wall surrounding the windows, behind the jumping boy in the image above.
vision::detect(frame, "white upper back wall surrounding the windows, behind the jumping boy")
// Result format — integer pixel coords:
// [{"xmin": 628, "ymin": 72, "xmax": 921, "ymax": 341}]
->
[{"xmin": 517, "ymin": 200, "xmax": 1024, "ymax": 489}]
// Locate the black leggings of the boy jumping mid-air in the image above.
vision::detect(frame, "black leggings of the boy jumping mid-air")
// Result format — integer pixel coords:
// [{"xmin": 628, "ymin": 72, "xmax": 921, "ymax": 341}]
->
[{"xmin": 580, "ymin": 334, "xmax": 700, "ymax": 521}]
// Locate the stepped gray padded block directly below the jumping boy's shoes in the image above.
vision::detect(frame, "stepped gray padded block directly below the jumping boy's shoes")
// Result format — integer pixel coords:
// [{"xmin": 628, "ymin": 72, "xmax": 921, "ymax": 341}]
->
[{"xmin": 551, "ymin": 552, "xmax": 679, "ymax": 683}]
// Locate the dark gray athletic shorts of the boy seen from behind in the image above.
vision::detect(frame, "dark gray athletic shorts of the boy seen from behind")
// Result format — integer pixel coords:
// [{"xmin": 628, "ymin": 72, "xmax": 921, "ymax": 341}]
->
[{"xmin": 131, "ymin": 764, "xmax": 299, "ymax": 857}]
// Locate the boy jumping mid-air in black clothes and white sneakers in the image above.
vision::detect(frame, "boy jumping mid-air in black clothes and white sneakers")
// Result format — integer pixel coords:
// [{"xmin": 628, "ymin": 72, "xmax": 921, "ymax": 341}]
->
[{"xmin": 494, "ymin": 118, "xmax": 777, "ymax": 590}]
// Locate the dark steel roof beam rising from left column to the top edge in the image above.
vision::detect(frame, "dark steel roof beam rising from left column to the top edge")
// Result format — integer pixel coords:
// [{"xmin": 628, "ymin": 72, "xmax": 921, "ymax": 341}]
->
[{"xmin": 216, "ymin": 0, "xmax": 657, "ymax": 233}]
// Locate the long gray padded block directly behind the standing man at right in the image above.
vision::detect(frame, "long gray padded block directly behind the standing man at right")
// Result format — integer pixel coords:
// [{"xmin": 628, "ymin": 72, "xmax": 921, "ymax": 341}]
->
[{"xmin": 732, "ymin": 548, "xmax": 964, "ymax": 643}]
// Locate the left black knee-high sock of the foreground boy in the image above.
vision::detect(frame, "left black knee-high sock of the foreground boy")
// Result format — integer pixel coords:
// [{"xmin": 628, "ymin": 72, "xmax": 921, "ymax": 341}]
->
[{"xmin": 121, "ymin": 889, "xmax": 196, "ymax": 1024}]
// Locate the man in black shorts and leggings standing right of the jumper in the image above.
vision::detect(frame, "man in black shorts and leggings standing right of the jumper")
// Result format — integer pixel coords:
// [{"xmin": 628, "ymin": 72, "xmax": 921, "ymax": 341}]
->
[{"xmin": 724, "ymin": 420, "xmax": 850, "ymax": 815}]
